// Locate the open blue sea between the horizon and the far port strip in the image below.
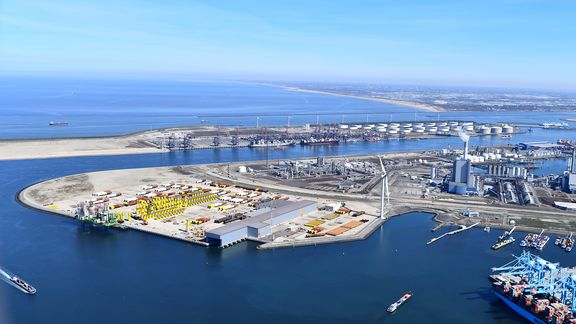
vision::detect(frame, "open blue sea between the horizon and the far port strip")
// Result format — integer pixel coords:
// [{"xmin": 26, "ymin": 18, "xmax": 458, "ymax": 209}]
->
[{"xmin": 0, "ymin": 77, "xmax": 576, "ymax": 139}]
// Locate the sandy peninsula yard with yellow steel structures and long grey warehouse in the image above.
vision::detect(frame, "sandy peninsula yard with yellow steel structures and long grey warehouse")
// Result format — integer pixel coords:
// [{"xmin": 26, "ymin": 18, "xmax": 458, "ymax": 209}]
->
[{"xmin": 20, "ymin": 167, "xmax": 381, "ymax": 247}]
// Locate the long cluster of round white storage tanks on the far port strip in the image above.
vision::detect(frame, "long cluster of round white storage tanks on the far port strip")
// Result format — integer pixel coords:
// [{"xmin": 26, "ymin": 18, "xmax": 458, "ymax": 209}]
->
[{"xmin": 339, "ymin": 121, "xmax": 514, "ymax": 135}]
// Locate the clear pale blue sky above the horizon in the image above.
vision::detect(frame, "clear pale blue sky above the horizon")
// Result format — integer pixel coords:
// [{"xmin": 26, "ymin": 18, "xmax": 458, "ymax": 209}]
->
[{"xmin": 0, "ymin": 0, "xmax": 576, "ymax": 90}]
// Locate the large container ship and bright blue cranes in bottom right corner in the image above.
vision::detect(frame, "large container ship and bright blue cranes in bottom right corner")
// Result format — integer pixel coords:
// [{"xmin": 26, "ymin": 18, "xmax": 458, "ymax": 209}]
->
[{"xmin": 490, "ymin": 251, "xmax": 576, "ymax": 324}]
